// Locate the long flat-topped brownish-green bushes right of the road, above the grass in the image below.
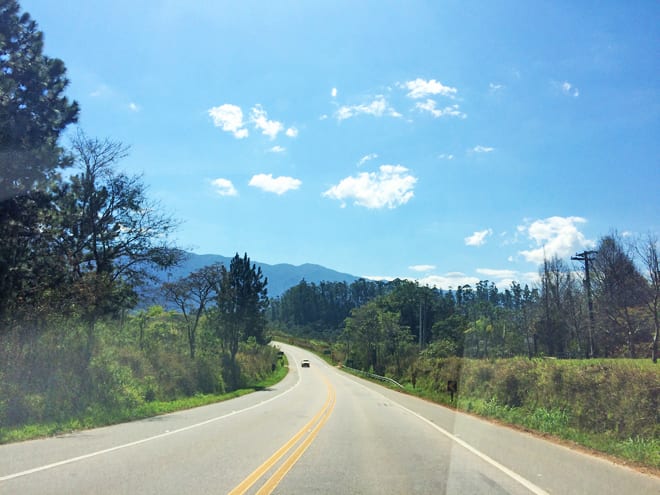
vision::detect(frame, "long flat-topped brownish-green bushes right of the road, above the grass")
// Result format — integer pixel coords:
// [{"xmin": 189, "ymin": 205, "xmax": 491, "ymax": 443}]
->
[{"xmin": 411, "ymin": 358, "xmax": 660, "ymax": 440}]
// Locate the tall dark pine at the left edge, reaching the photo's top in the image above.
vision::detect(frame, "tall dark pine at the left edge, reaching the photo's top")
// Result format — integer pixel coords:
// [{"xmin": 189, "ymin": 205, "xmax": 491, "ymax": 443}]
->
[{"xmin": 0, "ymin": 0, "xmax": 78, "ymax": 331}]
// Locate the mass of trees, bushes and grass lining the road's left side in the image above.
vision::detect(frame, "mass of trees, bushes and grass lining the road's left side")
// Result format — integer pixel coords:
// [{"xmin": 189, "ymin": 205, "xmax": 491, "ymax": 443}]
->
[{"xmin": 0, "ymin": 0, "xmax": 283, "ymax": 441}]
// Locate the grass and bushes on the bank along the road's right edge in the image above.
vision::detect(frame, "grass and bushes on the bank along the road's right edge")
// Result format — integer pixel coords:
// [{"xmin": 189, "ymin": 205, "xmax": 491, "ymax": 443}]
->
[{"xmin": 284, "ymin": 334, "xmax": 660, "ymax": 473}]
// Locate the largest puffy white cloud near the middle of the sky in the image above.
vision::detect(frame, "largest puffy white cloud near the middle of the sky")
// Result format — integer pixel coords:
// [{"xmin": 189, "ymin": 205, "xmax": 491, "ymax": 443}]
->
[{"xmin": 323, "ymin": 165, "xmax": 417, "ymax": 208}]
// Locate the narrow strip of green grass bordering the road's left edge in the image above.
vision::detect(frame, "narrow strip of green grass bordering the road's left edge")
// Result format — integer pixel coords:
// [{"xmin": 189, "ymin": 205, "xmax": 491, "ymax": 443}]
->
[{"xmin": 0, "ymin": 357, "xmax": 289, "ymax": 444}]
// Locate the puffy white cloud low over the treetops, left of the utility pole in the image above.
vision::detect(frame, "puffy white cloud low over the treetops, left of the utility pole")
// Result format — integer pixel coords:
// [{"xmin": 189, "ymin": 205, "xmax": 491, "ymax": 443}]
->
[{"xmin": 518, "ymin": 216, "xmax": 595, "ymax": 264}]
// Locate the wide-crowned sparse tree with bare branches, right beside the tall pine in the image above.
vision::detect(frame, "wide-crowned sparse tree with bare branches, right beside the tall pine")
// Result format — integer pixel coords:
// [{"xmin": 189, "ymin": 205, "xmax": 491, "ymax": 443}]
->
[{"xmin": 57, "ymin": 132, "xmax": 181, "ymax": 357}]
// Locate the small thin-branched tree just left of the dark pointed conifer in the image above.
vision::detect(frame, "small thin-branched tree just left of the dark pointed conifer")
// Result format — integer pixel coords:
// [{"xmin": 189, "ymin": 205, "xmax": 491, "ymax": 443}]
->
[{"xmin": 163, "ymin": 263, "xmax": 222, "ymax": 359}]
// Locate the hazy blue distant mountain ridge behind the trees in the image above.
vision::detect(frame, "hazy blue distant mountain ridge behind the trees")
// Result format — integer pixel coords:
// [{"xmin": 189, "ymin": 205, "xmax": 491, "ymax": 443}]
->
[{"xmin": 150, "ymin": 253, "xmax": 359, "ymax": 297}]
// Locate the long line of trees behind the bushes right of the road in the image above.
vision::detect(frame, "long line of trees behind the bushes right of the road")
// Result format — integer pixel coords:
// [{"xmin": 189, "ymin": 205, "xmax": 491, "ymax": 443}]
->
[{"xmin": 269, "ymin": 233, "xmax": 660, "ymax": 371}]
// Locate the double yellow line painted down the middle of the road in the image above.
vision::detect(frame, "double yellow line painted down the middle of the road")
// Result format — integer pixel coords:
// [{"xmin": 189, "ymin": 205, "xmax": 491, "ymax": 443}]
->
[{"xmin": 229, "ymin": 378, "xmax": 336, "ymax": 495}]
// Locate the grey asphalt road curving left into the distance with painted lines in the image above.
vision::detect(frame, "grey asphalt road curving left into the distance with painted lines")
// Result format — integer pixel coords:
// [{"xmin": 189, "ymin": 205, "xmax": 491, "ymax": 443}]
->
[{"xmin": 0, "ymin": 344, "xmax": 660, "ymax": 495}]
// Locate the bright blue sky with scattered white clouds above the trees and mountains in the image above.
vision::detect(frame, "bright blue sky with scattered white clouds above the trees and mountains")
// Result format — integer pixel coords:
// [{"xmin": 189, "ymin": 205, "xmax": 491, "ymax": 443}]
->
[{"xmin": 21, "ymin": 0, "xmax": 660, "ymax": 289}]
